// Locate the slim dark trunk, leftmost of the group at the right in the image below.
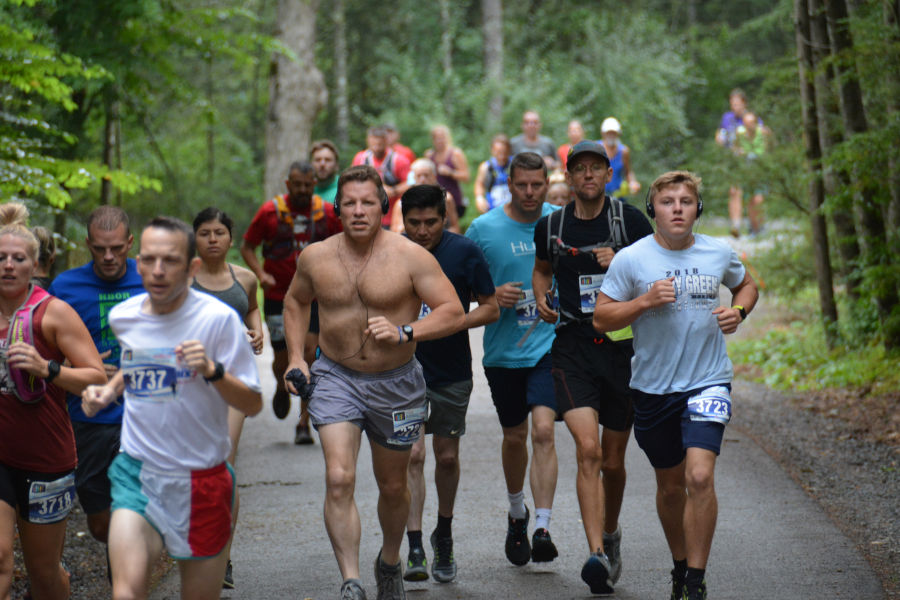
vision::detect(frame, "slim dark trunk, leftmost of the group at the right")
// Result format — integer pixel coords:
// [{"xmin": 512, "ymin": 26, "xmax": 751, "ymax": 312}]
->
[{"xmin": 794, "ymin": 0, "xmax": 838, "ymax": 347}]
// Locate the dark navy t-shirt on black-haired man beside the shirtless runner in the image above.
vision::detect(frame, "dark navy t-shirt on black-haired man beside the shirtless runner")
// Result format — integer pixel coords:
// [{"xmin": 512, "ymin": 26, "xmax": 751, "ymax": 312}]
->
[{"xmin": 416, "ymin": 231, "xmax": 495, "ymax": 388}]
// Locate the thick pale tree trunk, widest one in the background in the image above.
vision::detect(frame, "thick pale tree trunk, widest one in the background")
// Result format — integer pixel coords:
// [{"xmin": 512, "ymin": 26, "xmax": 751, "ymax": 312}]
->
[{"xmin": 265, "ymin": 0, "xmax": 328, "ymax": 198}]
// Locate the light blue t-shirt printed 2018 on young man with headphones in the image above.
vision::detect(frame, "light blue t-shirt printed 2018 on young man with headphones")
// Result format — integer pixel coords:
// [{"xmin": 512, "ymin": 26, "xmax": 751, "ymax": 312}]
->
[{"xmin": 600, "ymin": 234, "xmax": 744, "ymax": 398}]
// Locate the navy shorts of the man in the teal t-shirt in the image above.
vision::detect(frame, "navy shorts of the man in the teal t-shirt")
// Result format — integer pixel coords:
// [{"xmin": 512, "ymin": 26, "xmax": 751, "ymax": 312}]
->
[{"xmin": 484, "ymin": 354, "xmax": 557, "ymax": 427}]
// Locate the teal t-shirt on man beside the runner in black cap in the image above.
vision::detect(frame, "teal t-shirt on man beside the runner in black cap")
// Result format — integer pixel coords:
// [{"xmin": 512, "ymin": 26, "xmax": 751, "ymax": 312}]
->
[{"xmin": 466, "ymin": 203, "xmax": 558, "ymax": 369}]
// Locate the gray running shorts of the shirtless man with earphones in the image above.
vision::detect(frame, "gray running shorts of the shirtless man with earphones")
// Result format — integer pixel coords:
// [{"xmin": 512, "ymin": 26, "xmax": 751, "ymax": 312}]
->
[{"xmin": 309, "ymin": 354, "xmax": 425, "ymax": 450}]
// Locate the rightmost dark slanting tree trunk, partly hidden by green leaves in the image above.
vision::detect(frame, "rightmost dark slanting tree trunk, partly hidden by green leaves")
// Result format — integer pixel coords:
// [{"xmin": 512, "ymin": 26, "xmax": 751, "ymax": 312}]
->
[{"xmin": 828, "ymin": 0, "xmax": 900, "ymax": 348}]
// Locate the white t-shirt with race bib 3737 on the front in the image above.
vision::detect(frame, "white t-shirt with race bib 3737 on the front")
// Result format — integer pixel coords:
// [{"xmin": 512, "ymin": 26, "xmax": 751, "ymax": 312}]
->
[{"xmin": 109, "ymin": 289, "xmax": 260, "ymax": 470}]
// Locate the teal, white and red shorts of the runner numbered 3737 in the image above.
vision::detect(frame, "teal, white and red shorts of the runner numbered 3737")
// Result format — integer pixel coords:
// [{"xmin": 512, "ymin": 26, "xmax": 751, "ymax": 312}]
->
[{"xmin": 109, "ymin": 452, "xmax": 235, "ymax": 560}]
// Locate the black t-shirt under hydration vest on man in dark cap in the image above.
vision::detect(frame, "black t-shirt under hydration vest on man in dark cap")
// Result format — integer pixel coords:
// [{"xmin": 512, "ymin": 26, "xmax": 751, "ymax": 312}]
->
[{"xmin": 534, "ymin": 196, "xmax": 653, "ymax": 335}]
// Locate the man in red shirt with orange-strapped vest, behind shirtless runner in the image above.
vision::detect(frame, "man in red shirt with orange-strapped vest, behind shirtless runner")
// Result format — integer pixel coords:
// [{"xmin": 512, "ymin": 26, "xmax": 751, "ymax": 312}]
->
[{"xmin": 241, "ymin": 161, "xmax": 341, "ymax": 444}]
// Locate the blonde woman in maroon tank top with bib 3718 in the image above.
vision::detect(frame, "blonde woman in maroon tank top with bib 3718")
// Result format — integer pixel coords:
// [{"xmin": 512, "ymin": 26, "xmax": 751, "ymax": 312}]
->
[{"xmin": 0, "ymin": 202, "xmax": 106, "ymax": 600}]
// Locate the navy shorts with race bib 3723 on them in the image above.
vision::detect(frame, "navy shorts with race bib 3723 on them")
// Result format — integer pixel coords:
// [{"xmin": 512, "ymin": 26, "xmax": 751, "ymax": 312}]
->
[{"xmin": 632, "ymin": 385, "xmax": 731, "ymax": 469}]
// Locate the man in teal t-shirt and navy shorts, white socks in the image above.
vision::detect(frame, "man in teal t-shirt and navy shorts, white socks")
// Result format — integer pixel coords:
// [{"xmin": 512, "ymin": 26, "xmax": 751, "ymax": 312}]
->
[{"xmin": 466, "ymin": 152, "xmax": 557, "ymax": 566}]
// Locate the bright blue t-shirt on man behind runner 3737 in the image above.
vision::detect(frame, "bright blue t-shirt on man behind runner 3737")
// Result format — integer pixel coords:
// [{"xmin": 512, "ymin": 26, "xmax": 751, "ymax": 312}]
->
[{"xmin": 47, "ymin": 258, "xmax": 145, "ymax": 423}]
